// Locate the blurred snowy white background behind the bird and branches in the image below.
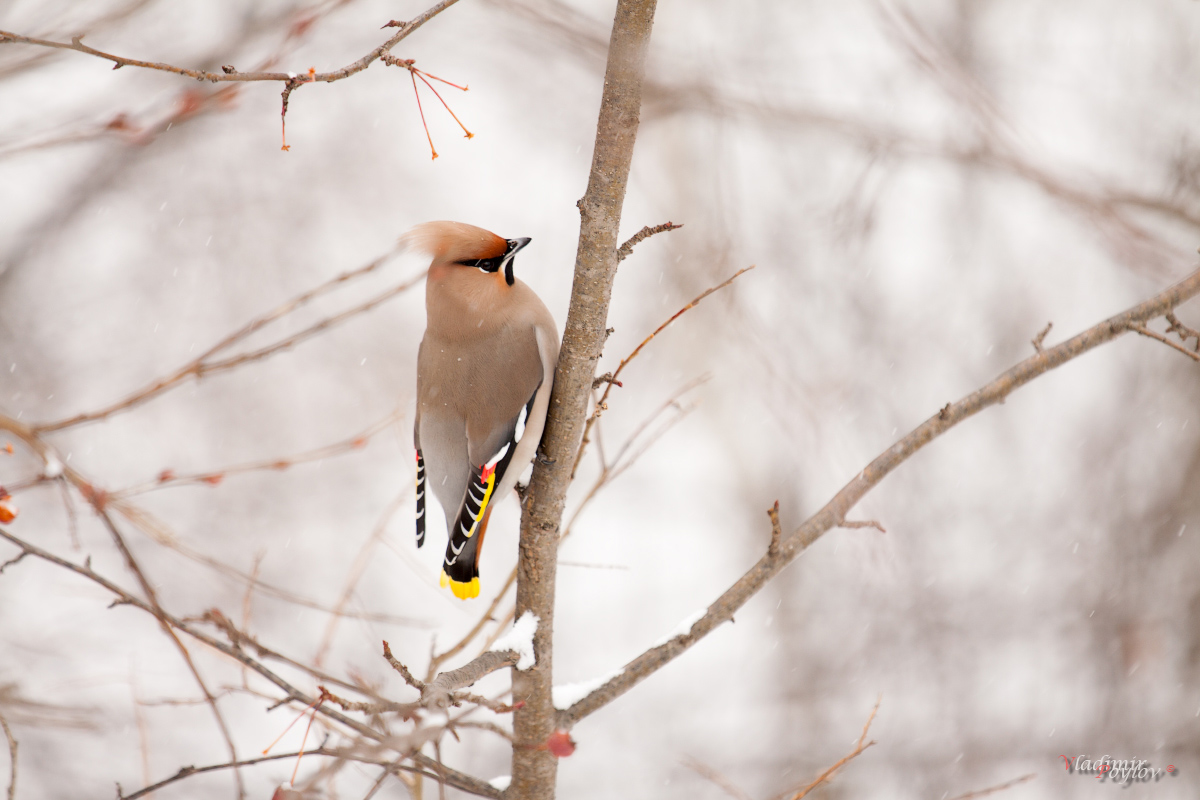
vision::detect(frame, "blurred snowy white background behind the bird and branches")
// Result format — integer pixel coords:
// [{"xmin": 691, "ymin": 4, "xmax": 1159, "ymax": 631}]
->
[{"xmin": 0, "ymin": 0, "xmax": 1200, "ymax": 800}]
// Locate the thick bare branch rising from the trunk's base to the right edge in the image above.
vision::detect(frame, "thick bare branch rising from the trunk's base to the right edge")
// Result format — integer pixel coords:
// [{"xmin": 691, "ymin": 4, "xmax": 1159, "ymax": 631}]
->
[{"xmin": 558, "ymin": 270, "xmax": 1200, "ymax": 728}]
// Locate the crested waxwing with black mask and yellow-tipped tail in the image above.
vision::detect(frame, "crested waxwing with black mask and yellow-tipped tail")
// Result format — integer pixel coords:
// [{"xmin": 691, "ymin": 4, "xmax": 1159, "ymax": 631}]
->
[{"xmin": 402, "ymin": 222, "xmax": 558, "ymax": 600}]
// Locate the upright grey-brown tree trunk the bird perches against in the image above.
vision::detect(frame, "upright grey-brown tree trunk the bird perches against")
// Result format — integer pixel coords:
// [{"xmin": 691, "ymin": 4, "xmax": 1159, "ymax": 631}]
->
[{"xmin": 508, "ymin": 0, "xmax": 656, "ymax": 800}]
